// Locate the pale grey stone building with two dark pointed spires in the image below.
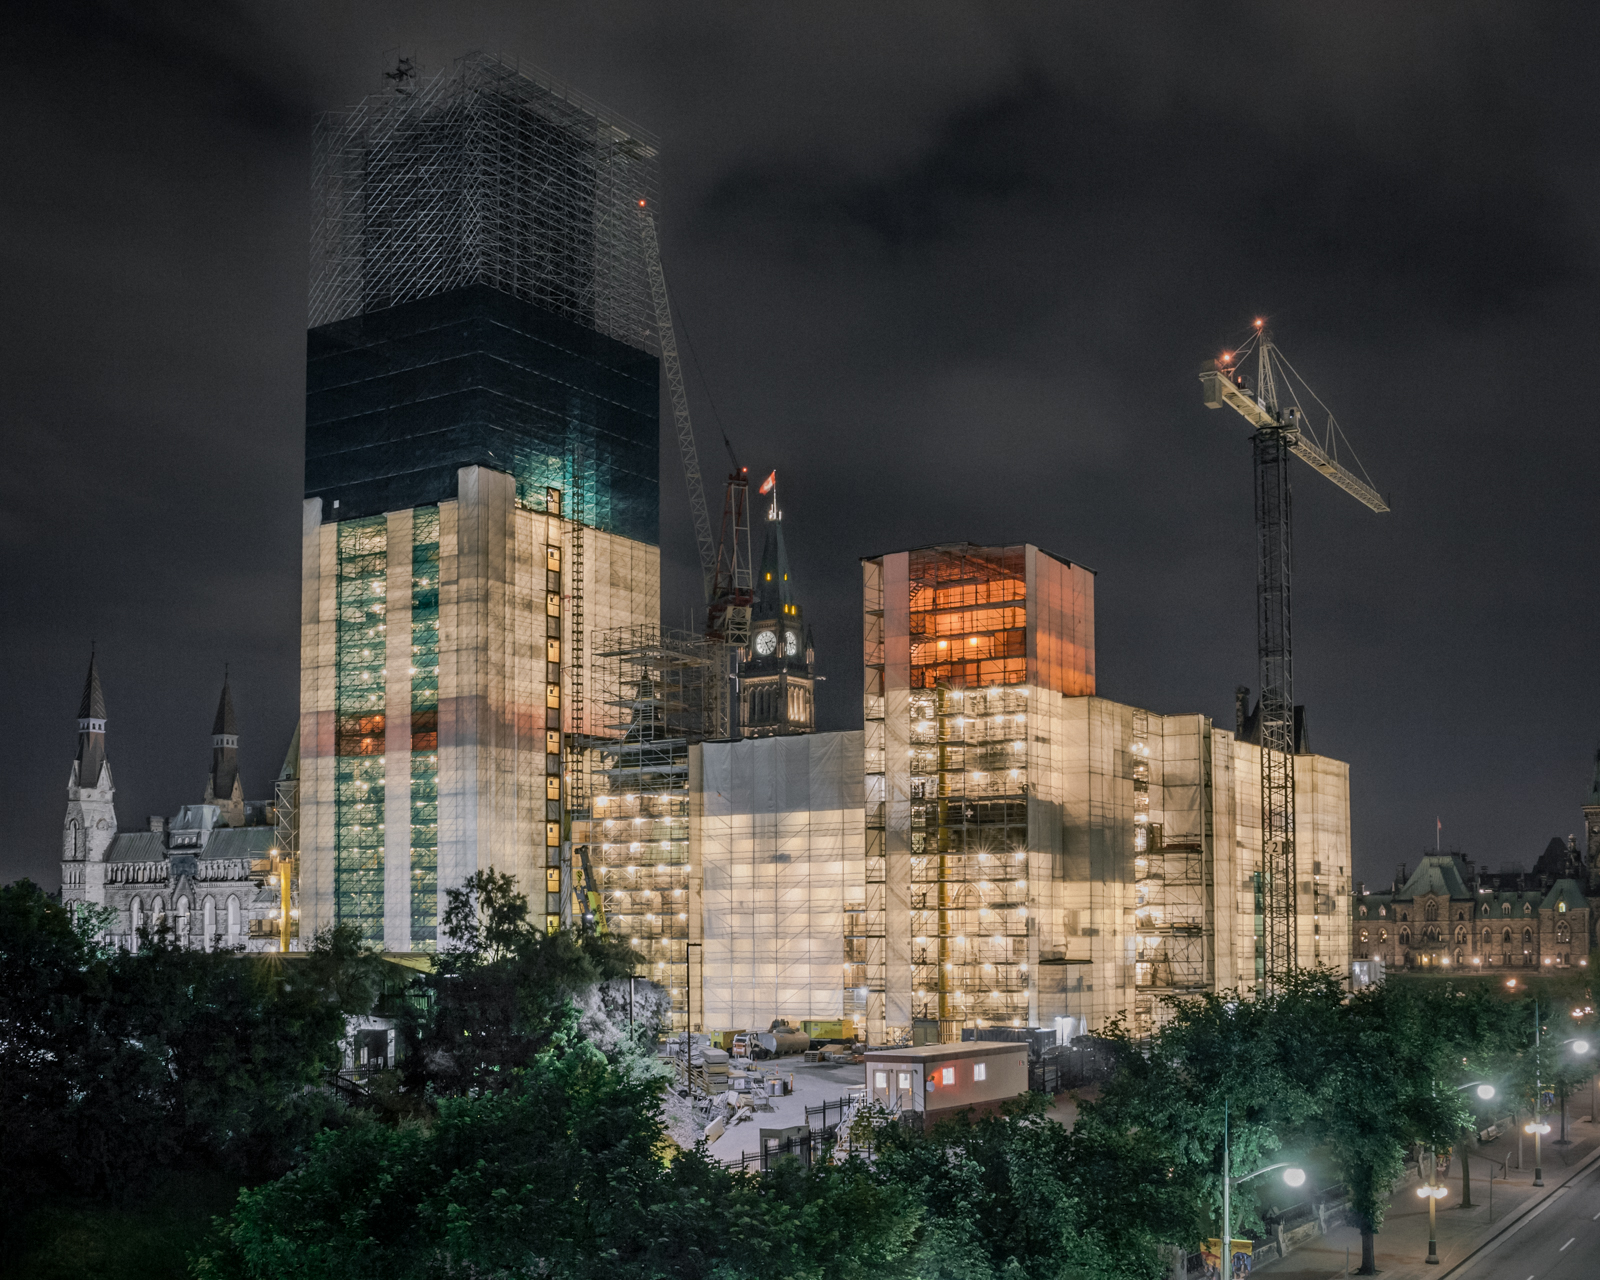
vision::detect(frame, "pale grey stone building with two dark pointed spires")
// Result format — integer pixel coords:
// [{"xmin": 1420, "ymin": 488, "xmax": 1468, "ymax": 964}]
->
[{"xmin": 61, "ymin": 659, "xmax": 294, "ymax": 950}]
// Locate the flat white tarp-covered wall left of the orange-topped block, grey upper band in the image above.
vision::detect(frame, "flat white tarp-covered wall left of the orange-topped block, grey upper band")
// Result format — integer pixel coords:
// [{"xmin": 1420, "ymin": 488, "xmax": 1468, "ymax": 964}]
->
[{"xmin": 690, "ymin": 731, "xmax": 866, "ymax": 1029}]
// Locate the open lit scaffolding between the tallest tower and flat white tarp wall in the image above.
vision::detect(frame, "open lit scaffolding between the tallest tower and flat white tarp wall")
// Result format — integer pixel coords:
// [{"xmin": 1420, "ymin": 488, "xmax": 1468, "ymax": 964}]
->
[{"xmin": 573, "ymin": 626, "xmax": 715, "ymax": 1030}]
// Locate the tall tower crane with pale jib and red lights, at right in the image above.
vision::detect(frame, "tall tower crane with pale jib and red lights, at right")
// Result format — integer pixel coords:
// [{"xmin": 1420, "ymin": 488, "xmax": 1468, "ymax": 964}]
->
[{"xmin": 1200, "ymin": 320, "xmax": 1389, "ymax": 984}]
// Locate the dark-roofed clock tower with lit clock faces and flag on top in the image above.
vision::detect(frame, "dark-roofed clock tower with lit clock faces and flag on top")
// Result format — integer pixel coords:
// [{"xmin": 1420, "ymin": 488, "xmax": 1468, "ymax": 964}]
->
[{"xmin": 739, "ymin": 472, "xmax": 816, "ymax": 738}]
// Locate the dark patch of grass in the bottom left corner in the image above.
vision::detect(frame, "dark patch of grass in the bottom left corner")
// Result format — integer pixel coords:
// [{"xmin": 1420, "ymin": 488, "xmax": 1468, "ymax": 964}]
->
[{"xmin": 0, "ymin": 1173, "xmax": 240, "ymax": 1280}]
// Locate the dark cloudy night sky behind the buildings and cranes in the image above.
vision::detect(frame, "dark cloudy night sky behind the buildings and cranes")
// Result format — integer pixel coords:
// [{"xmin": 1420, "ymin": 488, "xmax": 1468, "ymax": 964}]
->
[{"xmin": 0, "ymin": 0, "xmax": 1600, "ymax": 890}]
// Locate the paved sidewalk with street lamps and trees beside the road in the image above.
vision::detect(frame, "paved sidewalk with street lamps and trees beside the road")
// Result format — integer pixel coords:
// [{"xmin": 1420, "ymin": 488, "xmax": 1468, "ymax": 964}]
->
[{"xmin": 1256, "ymin": 1115, "xmax": 1600, "ymax": 1280}]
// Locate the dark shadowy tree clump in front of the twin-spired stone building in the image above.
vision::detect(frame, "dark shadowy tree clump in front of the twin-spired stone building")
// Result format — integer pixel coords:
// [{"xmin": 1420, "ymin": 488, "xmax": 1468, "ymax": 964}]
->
[{"xmin": 0, "ymin": 882, "xmax": 376, "ymax": 1205}]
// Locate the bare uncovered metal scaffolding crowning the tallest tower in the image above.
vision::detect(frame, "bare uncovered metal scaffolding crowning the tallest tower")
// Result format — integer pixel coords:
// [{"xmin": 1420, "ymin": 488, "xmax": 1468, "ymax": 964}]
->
[{"xmin": 309, "ymin": 53, "xmax": 658, "ymax": 352}]
